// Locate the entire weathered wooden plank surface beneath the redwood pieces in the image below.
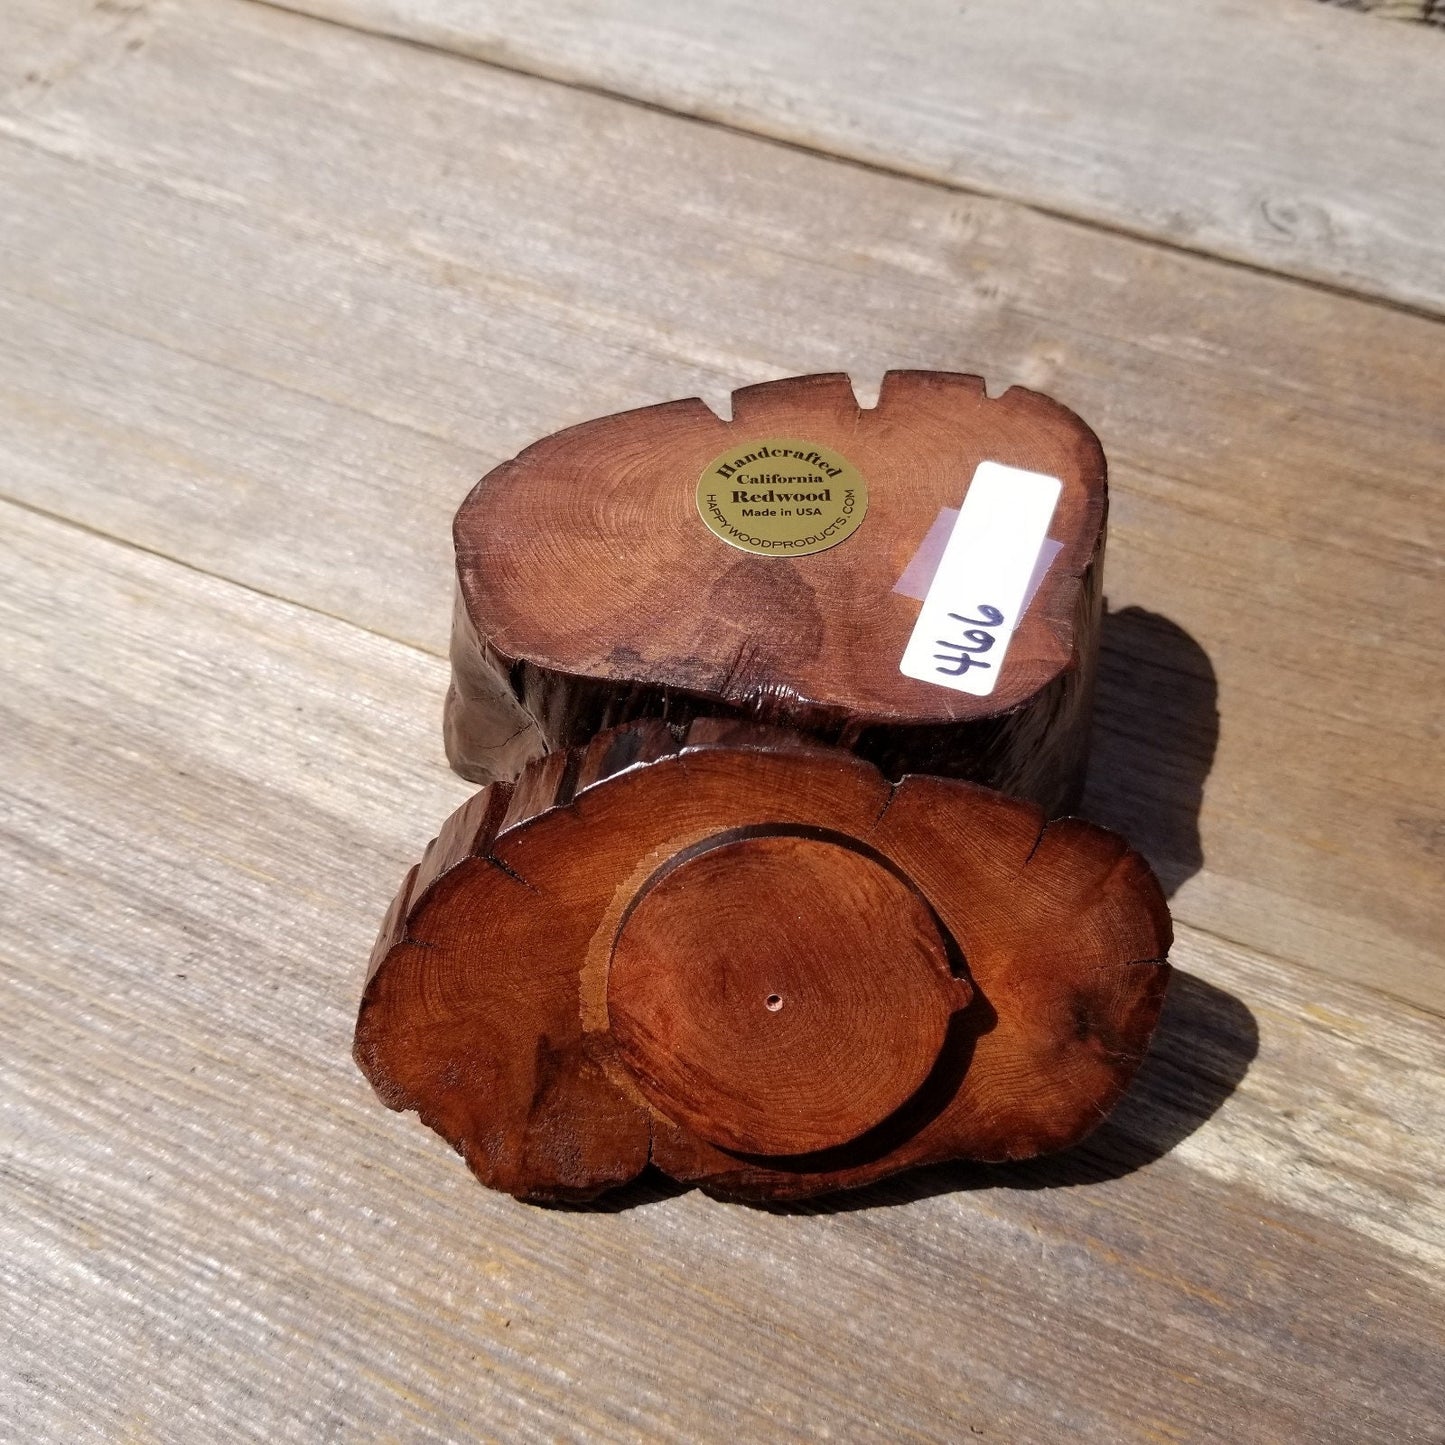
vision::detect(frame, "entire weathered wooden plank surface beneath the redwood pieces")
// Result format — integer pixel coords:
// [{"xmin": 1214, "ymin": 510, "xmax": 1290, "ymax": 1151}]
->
[{"xmin": 0, "ymin": 0, "xmax": 1445, "ymax": 1445}]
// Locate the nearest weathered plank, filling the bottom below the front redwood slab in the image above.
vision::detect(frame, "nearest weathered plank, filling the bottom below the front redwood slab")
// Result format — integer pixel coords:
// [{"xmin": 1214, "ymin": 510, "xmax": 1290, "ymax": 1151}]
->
[{"xmin": 0, "ymin": 506, "xmax": 1445, "ymax": 1445}]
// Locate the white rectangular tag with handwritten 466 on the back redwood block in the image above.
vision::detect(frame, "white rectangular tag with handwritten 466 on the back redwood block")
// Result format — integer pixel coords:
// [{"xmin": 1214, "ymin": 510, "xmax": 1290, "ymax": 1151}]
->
[{"xmin": 899, "ymin": 461, "xmax": 1064, "ymax": 698}]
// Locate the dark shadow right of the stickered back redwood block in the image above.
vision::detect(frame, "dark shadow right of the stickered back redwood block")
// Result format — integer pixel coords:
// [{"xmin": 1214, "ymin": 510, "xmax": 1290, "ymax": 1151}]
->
[{"xmin": 1081, "ymin": 604, "xmax": 1220, "ymax": 897}]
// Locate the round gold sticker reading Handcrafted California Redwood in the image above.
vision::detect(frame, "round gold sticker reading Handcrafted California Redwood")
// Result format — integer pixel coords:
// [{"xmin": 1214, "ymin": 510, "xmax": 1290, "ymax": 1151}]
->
[{"xmin": 698, "ymin": 436, "xmax": 868, "ymax": 556}]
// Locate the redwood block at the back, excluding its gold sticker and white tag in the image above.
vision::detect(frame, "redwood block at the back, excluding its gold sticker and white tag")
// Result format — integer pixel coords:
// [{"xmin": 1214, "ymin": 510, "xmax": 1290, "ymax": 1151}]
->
[{"xmin": 447, "ymin": 371, "xmax": 1107, "ymax": 814}]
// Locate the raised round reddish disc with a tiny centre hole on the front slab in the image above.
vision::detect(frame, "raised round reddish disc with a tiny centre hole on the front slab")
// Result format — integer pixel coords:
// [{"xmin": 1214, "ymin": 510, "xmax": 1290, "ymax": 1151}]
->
[{"xmin": 607, "ymin": 831, "xmax": 972, "ymax": 1155}]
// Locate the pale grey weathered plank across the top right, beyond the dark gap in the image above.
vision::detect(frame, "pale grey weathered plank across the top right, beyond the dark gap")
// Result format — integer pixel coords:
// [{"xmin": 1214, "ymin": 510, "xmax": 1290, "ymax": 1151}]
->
[{"xmin": 257, "ymin": 0, "xmax": 1445, "ymax": 314}]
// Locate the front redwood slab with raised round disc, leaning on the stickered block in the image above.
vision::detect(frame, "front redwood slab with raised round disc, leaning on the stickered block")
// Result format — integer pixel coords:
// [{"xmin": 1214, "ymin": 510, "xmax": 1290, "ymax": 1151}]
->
[{"xmin": 355, "ymin": 721, "xmax": 1170, "ymax": 1199}]
